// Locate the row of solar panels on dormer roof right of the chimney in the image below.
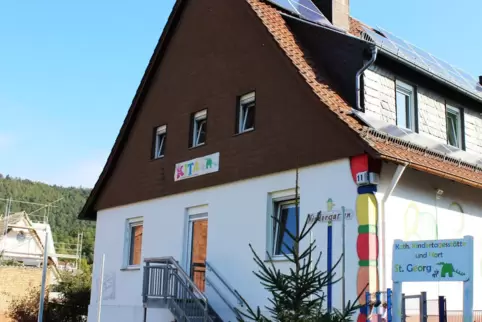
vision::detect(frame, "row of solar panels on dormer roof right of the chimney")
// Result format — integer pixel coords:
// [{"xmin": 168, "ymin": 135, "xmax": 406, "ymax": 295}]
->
[{"xmin": 363, "ymin": 27, "xmax": 482, "ymax": 99}]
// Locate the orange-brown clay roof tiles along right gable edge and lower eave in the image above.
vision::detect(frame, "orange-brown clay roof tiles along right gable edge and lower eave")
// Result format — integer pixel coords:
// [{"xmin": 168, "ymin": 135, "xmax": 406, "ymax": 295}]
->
[{"xmin": 247, "ymin": 0, "xmax": 482, "ymax": 188}]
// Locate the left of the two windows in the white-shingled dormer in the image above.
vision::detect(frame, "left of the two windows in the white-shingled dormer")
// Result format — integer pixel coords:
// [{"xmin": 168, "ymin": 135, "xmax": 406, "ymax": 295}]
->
[{"xmin": 396, "ymin": 80, "xmax": 416, "ymax": 132}]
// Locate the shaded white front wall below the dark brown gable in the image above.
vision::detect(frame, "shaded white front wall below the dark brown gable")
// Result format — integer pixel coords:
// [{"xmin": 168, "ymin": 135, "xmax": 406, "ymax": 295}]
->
[{"xmin": 89, "ymin": 160, "xmax": 358, "ymax": 322}]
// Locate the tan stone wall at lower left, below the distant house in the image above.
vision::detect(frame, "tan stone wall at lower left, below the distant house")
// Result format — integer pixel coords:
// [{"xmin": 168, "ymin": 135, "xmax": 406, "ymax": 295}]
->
[{"xmin": 0, "ymin": 266, "xmax": 51, "ymax": 322}]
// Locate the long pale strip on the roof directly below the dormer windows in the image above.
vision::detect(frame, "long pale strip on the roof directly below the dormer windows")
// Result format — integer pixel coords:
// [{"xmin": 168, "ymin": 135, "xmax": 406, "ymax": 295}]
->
[{"xmin": 353, "ymin": 110, "xmax": 482, "ymax": 167}]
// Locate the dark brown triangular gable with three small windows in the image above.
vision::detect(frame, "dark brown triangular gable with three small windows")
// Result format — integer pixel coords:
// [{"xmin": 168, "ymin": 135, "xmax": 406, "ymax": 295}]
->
[{"xmin": 80, "ymin": 0, "xmax": 367, "ymax": 219}]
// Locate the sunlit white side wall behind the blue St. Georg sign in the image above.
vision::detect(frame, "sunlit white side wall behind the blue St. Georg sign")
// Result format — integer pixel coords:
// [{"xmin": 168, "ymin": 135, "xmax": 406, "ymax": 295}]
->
[{"xmin": 377, "ymin": 165, "xmax": 482, "ymax": 310}]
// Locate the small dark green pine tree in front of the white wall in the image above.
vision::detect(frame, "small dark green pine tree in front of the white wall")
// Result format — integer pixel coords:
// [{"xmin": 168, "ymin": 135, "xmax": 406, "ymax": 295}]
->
[{"xmin": 237, "ymin": 171, "xmax": 363, "ymax": 322}]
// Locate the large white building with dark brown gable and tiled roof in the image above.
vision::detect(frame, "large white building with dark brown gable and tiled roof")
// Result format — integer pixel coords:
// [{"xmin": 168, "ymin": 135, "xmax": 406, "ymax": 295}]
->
[{"xmin": 80, "ymin": 0, "xmax": 482, "ymax": 321}]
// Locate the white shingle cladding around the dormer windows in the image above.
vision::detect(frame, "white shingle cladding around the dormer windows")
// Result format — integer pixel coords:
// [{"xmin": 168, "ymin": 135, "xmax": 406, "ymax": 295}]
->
[{"xmin": 364, "ymin": 65, "xmax": 482, "ymax": 155}]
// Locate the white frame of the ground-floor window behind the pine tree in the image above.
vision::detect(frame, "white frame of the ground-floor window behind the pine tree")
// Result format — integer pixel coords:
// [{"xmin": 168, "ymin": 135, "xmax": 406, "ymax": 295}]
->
[{"xmin": 266, "ymin": 189, "xmax": 301, "ymax": 261}]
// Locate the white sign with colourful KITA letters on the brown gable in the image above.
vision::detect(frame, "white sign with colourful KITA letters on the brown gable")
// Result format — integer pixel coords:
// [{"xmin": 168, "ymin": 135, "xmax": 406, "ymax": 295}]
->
[{"xmin": 174, "ymin": 152, "xmax": 219, "ymax": 181}]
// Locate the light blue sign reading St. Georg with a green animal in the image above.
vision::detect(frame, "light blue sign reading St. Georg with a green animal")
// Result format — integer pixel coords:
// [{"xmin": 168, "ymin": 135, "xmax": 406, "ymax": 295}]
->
[{"xmin": 392, "ymin": 238, "xmax": 473, "ymax": 282}]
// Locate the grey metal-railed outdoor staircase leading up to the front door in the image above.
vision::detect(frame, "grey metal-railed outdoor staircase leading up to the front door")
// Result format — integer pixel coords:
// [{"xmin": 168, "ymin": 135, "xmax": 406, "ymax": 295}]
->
[{"xmin": 142, "ymin": 257, "xmax": 241, "ymax": 322}]
